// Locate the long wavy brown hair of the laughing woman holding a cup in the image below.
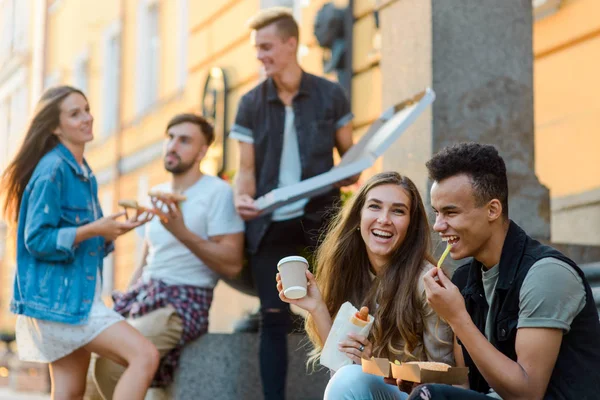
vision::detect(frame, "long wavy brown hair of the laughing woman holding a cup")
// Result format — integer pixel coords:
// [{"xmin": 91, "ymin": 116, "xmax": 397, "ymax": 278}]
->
[{"xmin": 306, "ymin": 172, "xmax": 436, "ymax": 366}]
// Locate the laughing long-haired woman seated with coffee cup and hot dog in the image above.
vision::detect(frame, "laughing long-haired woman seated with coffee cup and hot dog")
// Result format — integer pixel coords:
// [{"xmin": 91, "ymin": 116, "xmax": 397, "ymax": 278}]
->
[{"xmin": 277, "ymin": 172, "xmax": 454, "ymax": 400}]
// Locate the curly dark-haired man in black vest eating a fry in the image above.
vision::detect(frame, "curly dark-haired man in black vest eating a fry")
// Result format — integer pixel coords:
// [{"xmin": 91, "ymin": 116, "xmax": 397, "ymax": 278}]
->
[{"xmin": 411, "ymin": 143, "xmax": 600, "ymax": 400}]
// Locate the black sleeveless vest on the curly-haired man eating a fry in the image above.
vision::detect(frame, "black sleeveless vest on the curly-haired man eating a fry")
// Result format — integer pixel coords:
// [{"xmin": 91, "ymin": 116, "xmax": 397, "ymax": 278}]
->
[{"xmin": 452, "ymin": 221, "xmax": 600, "ymax": 400}]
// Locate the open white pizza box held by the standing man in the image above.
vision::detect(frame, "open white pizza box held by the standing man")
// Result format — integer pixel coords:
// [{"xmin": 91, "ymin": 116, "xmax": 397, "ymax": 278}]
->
[{"xmin": 254, "ymin": 88, "xmax": 435, "ymax": 215}]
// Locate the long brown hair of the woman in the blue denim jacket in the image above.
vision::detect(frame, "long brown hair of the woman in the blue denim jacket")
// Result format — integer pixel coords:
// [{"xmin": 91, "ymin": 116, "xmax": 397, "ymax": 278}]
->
[{"xmin": 0, "ymin": 86, "xmax": 85, "ymax": 227}]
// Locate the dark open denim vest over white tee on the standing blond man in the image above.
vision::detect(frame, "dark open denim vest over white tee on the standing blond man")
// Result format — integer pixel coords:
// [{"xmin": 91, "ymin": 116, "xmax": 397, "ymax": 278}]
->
[{"xmin": 241, "ymin": 72, "xmax": 341, "ymax": 253}]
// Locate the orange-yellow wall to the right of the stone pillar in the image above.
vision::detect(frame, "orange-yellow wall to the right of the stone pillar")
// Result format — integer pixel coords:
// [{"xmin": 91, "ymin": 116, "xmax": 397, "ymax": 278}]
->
[{"xmin": 534, "ymin": 0, "xmax": 600, "ymax": 197}]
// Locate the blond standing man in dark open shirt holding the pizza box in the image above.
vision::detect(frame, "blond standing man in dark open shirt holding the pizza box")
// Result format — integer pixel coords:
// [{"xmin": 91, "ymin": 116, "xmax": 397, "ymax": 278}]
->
[{"xmin": 230, "ymin": 8, "xmax": 358, "ymax": 399}]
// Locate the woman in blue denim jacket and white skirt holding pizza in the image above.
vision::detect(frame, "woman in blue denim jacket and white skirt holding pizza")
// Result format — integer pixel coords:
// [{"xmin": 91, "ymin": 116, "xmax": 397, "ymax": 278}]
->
[{"xmin": 2, "ymin": 86, "xmax": 159, "ymax": 400}]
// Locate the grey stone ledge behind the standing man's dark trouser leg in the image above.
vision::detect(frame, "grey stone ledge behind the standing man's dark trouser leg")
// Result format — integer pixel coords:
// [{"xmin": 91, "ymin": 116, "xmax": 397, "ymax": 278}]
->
[{"xmin": 174, "ymin": 333, "xmax": 329, "ymax": 400}]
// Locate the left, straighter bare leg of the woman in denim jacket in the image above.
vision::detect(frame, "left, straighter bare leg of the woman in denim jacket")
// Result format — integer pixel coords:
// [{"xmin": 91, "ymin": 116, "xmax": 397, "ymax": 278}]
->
[{"xmin": 50, "ymin": 348, "xmax": 90, "ymax": 400}]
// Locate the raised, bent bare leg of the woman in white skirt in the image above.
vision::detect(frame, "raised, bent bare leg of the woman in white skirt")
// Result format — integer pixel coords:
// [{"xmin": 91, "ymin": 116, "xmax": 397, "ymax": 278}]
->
[{"xmin": 85, "ymin": 321, "xmax": 160, "ymax": 400}]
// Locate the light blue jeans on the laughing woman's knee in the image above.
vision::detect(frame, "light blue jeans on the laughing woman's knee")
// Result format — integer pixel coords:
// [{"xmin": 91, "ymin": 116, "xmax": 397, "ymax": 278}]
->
[{"xmin": 323, "ymin": 365, "xmax": 408, "ymax": 400}]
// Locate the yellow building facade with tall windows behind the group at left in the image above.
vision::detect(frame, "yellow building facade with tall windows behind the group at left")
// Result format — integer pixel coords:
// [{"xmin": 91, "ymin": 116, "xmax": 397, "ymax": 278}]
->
[{"xmin": 0, "ymin": 0, "xmax": 381, "ymax": 331}]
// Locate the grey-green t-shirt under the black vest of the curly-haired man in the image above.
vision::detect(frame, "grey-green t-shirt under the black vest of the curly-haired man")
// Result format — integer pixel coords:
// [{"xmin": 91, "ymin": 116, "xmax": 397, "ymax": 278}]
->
[{"xmin": 482, "ymin": 257, "xmax": 585, "ymax": 399}]
